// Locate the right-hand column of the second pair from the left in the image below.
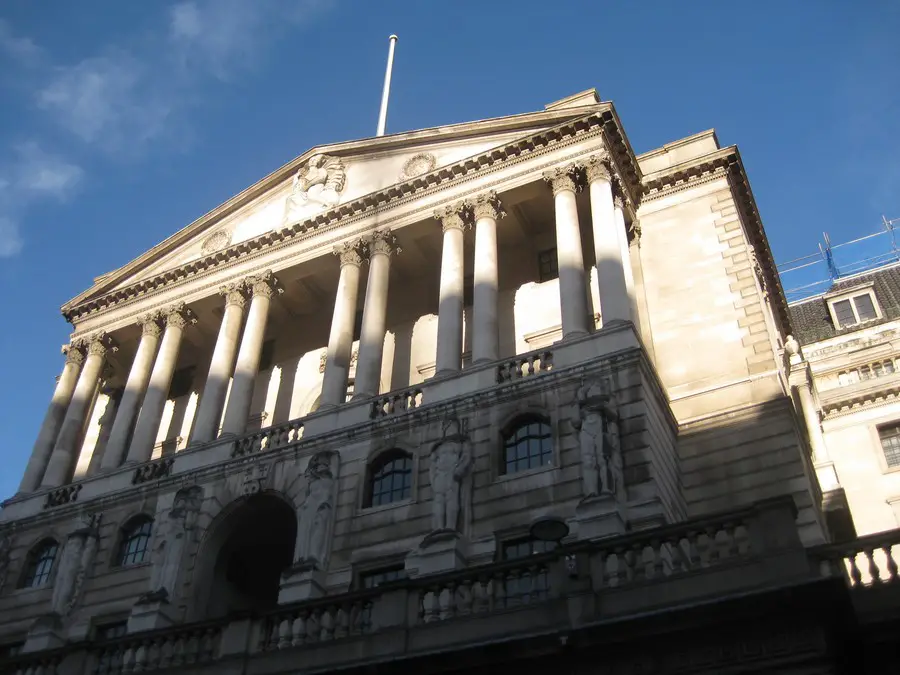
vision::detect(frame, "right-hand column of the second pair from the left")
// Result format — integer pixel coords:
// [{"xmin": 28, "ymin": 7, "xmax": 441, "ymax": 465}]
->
[{"xmin": 126, "ymin": 303, "xmax": 196, "ymax": 462}]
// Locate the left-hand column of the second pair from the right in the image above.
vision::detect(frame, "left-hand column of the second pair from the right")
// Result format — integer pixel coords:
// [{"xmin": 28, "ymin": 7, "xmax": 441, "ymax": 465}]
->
[{"xmin": 434, "ymin": 202, "xmax": 469, "ymax": 377}]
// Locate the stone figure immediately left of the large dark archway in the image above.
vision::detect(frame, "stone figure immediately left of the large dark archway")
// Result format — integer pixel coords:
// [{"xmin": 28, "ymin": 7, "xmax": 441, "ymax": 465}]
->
[{"xmin": 138, "ymin": 485, "xmax": 203, "ymax": 603}]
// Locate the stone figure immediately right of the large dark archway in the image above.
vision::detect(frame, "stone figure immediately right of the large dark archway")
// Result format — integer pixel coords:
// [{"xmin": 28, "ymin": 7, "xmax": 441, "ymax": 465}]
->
[{"xmin": 294, "ymin": 452, "xmax": 337, "ymax": 569}]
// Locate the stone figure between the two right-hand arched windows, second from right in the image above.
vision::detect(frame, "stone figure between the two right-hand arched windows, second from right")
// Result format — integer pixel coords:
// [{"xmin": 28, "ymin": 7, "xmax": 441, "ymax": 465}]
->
[{"xmin": 429, "ymin": 418, "xmax": 472, "ymax": 532}]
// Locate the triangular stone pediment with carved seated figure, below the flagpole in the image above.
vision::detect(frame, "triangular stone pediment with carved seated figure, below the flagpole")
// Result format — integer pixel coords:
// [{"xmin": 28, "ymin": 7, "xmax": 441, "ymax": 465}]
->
[{"xmin": 63, "ymin": 90, "xmax": 605, "ymax": 312}]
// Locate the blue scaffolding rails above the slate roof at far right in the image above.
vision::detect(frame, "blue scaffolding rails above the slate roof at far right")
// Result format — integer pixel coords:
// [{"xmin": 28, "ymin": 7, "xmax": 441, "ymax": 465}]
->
[{"xmin": 776, "ymin": 216, "xmax": 900, "ymax": 302}]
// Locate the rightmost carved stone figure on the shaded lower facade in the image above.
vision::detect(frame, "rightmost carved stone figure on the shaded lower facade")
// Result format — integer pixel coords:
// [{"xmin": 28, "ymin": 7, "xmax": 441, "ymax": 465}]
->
[{"xmin": 574, "ymin": 380, "xmax": 623, "ymax": 499}]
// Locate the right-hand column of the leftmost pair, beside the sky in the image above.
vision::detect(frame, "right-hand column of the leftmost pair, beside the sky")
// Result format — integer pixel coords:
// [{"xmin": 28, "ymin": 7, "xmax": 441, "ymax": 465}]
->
[{"xmin": 41, "ymin": 333, "xmax": 115, "ymax": 488}]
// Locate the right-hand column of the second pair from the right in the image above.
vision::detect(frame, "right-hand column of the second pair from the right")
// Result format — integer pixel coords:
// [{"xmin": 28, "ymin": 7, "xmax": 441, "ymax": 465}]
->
[{"xmin": 472, "ymin": 192, "xmax": 506, "ymax": 363}]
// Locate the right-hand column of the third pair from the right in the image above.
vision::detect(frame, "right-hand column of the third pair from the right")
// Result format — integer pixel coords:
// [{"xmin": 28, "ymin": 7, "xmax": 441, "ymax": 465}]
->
[{"xmin": 353, "ymin": 229, "xmax": 400, "ymax": 398}]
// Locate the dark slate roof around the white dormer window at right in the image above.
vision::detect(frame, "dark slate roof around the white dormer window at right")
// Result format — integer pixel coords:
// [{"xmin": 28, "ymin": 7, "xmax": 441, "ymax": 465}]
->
[{"xmin": 788, "ymin": 263, "xmax": 900, "ymax": 344}]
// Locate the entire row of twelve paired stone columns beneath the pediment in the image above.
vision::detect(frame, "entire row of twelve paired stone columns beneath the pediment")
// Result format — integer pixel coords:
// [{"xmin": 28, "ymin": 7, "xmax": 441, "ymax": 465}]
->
[{"xmin": 19, "ymin": 155, "xmax": 636, "ymax": 493}]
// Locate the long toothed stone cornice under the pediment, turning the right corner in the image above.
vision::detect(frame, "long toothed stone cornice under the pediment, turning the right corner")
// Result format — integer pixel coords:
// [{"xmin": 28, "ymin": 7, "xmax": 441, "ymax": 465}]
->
[{"xmin": 62, "ymin": 104, "xmax": 641, "ymax": 324}]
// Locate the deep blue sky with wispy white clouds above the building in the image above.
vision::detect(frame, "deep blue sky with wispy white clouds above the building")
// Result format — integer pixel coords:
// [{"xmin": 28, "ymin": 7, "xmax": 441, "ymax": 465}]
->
[{"xmin": 0, "ymin": 0, "xmax": 900, "ymax": 496}]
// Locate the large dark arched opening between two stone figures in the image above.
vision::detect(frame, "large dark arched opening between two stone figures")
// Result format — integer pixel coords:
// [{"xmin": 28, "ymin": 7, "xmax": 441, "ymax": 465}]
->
[{"xmin": 194, "ymin": 493, "xmax": 297, "ymax": 619}]
